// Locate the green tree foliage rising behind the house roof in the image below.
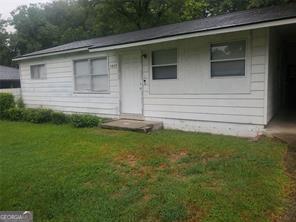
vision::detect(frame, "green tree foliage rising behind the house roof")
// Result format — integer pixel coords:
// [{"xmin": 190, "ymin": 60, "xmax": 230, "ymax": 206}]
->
[{"xmin": 0, "ymin": 0, "xmax": 289, "ymax": 65}]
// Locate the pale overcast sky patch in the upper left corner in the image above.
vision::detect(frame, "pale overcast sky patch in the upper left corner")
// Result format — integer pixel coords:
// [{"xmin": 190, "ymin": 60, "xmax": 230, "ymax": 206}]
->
[{"xmin": 0, "ymin": 0, "xmax": 53, "ymax": 31}]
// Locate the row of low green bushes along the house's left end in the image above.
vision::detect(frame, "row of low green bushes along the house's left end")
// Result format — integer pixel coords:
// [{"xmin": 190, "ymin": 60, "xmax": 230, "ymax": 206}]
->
[{"xmin": 0, "ymin": 93, "xmax": 103, "ymax": 128}]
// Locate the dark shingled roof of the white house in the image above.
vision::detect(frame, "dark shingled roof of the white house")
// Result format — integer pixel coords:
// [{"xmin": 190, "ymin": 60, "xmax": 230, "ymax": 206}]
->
[{"xmin": 16, "ymin": 3, "xmax": 296, "ymax": 57}]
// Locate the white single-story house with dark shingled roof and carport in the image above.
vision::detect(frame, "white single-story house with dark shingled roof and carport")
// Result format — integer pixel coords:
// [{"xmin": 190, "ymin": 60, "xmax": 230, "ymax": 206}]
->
[{"xmin": 14, "ymin": 4, "xmax": 296, "ymax": 136}]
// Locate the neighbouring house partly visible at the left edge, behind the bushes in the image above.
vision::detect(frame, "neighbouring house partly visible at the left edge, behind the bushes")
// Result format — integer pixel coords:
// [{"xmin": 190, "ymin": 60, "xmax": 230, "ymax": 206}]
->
[{"xmin": 0, "ymin": 65, "xmax": 20, "ymax": 89}]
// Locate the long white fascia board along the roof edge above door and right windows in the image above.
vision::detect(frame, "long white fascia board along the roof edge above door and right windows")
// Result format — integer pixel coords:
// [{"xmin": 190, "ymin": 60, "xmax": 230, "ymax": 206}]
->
[{"xmin": 89, "ymin": 18, "xmax": 296, "ymax": 52}]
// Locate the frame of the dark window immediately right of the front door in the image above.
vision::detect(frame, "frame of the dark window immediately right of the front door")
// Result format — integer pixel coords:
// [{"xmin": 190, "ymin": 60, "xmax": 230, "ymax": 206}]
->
[{"xmin": 150, "ymin": 47, "xmax": 179, "ymax": 81}]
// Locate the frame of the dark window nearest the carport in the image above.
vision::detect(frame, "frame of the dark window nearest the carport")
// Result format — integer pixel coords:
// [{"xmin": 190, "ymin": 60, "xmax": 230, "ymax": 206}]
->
[{"xmin": 208, "ymin": 39, "xmax": 249, "ymax": 78}]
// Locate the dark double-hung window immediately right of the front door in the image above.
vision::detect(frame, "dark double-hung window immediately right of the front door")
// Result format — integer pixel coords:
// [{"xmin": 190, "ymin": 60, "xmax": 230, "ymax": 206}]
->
[{"xmin": 152, "ymin": 49, "xmax": 177, "ymax": 80}]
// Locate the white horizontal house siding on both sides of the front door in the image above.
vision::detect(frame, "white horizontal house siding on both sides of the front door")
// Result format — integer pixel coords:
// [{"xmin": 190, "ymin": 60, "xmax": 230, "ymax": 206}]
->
[{"xmin": 20, "ymin": 29, "xmax": 268, "ymax": 136}]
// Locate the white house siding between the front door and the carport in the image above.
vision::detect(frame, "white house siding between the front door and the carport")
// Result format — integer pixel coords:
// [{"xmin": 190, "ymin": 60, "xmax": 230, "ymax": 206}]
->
[{"xmin": 143, "ymin": 29, "xmax": 268, "ymax": 136}]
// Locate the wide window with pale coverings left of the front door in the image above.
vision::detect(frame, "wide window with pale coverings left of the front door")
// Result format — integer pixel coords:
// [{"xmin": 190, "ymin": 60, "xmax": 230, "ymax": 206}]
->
[{"xmin": 74, "ymin": 58, "xmax": 109, "ymax": 92}]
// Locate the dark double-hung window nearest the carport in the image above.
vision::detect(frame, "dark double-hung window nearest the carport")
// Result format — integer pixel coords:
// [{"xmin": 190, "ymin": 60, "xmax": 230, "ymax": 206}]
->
[{"xmin": 211, "ymin": 41, "xmax": 246, "ymax": 77}]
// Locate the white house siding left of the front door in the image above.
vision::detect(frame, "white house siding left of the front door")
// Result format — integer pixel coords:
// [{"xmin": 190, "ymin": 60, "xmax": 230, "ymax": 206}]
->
[{"xmin": 20, "ymin": 53, "xmax": 119, "ymax": 117}]
